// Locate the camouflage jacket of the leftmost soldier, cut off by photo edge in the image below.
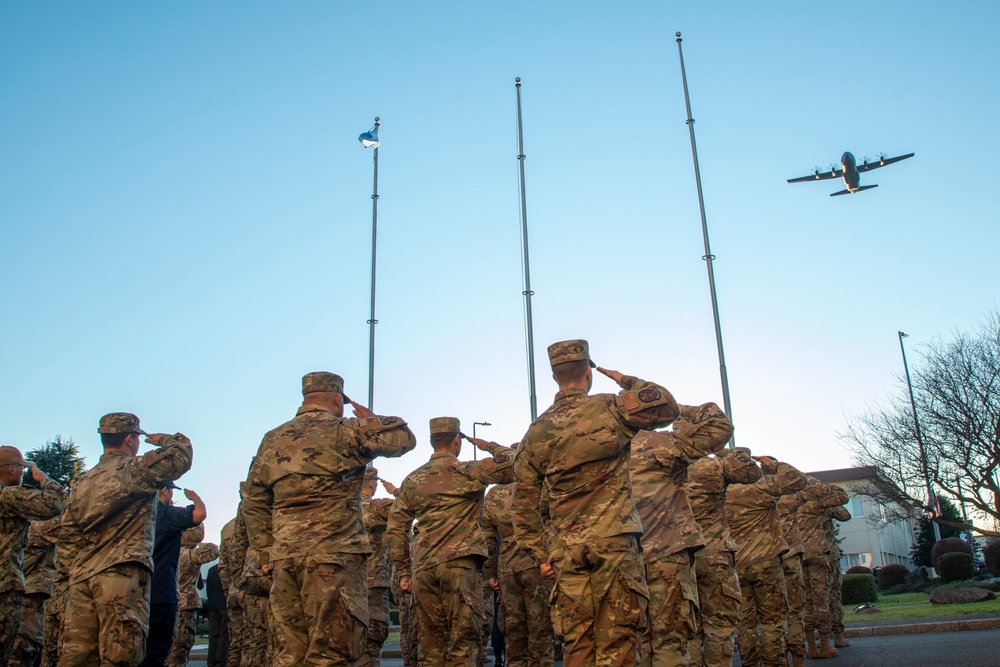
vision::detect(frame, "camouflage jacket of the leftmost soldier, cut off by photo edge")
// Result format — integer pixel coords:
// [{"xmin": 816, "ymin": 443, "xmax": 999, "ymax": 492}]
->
[{"xmin": 0, "ymin": 478, "xmax": 66, "ymax": 593}]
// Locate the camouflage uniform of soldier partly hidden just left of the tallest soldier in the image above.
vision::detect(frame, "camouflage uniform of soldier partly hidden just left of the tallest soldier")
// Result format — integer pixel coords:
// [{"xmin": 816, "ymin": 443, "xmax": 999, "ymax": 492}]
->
[{"xmin": 483, "ymin": 484, "xmax": 553, "ymax": 667}]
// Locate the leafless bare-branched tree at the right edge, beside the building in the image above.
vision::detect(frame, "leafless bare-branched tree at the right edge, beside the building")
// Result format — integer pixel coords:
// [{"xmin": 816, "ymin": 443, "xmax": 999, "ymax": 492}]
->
[{"xmin": 839, "ymin": 309, "xmax": 1000, "ymax": 534}]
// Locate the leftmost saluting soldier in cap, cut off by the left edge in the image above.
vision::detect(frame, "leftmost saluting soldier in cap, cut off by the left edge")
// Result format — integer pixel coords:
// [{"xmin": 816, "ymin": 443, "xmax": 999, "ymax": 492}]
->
[{"xmin": 0, "ymin": 445, "xmax": 66, "ymax": 665}]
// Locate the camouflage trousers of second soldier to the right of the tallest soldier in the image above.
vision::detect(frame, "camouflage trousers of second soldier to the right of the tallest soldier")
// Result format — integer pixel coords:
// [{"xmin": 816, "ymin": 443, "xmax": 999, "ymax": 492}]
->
[{"xmin": 688, "ymin": 551, "xmax": 742, "ymax": 667}]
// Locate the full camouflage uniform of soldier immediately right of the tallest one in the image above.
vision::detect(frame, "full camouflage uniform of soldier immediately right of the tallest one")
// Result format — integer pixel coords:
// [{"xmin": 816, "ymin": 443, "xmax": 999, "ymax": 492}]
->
[{"xmin": 629, "ymin": 403, "xmax": 733, "ymax": 667}]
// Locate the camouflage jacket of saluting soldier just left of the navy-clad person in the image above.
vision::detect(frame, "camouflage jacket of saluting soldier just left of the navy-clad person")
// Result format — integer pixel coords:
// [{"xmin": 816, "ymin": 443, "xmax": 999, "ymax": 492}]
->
[{"xmin": 59, "ymin": 433, "xmax": 192, "ymax": 585}]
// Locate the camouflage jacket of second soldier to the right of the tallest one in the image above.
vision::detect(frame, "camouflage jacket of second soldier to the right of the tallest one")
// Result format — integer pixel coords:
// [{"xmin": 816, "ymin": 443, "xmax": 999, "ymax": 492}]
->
[{"xmin": 685, "ymin": 451, "xmax": 761, "ymax": 557}]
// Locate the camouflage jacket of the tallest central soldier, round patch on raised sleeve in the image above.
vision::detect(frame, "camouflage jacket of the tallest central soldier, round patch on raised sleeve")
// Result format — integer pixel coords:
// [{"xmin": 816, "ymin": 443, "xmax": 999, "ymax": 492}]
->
[{"xmin": 514, "ymin": 376, "xmax": 678, "ymax": 563}]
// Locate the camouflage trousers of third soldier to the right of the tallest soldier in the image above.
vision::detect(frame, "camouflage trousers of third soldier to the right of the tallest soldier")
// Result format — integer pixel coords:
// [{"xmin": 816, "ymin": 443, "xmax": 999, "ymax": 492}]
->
[{"xmin": 738, "ymin": 558, "xmax": 788, "ymax": 667}]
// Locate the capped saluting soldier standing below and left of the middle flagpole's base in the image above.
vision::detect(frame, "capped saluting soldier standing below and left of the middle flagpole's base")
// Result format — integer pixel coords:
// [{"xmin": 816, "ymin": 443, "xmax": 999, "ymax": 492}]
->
[{"xmin": 386, "ymin": 417, "xmax": 514, "ymax": 667}]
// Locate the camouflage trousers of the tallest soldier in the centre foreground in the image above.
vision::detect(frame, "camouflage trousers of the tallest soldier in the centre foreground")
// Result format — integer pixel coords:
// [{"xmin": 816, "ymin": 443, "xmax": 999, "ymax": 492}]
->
[{"xmin": 551, "ymin": 535, "xmax": 649, "ymax": 667}]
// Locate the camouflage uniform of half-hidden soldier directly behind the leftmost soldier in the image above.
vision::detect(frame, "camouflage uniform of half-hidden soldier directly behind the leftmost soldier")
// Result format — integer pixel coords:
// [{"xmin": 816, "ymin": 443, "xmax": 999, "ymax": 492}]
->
[{"xmin": 9, "ymin": 515, "xmax": 62, "ymax": 667}]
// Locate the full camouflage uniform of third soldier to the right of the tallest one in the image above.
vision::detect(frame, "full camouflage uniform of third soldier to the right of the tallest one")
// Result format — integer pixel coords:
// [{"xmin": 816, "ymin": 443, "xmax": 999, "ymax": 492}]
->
[{"xmin": 726, "ymin": 462, "xmax": 806, "ymax": 667}]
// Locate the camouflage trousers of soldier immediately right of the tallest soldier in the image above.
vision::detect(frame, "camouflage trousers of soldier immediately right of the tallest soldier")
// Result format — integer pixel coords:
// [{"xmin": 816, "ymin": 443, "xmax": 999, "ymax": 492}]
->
[{"xmin": 639, "ymin": 551, "xmax": 698, "ymax": 667}]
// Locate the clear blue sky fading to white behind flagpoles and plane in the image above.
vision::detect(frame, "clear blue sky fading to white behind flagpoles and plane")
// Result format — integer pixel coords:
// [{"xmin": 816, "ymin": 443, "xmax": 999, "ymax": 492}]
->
[{"xmin": 0, "ymin": 1, "xmax": 1000, "ymax": 539}]
